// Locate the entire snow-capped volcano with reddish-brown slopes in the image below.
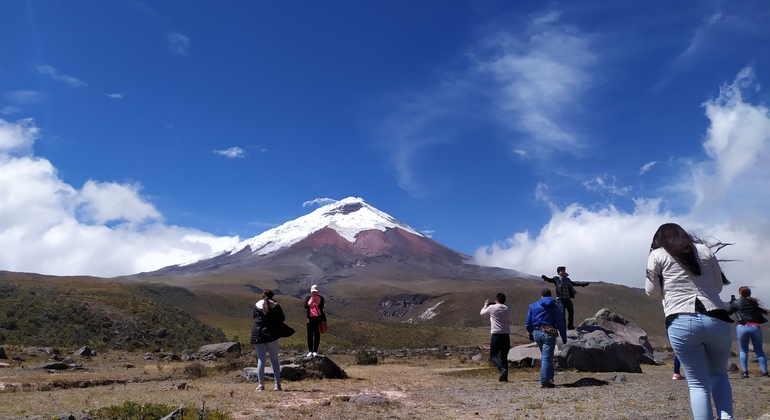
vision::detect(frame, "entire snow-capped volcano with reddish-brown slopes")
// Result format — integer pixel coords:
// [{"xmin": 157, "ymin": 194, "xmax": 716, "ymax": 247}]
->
[{"xmin": 139, "ymin": 197, "xmax": 516, "ymax": 293}]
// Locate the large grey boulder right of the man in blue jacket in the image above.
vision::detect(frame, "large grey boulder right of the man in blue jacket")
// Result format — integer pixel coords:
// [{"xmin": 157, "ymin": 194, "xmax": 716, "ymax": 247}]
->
[{"xmin": 554, "ymin": 308, "xmax": 656, "ymax": 373}]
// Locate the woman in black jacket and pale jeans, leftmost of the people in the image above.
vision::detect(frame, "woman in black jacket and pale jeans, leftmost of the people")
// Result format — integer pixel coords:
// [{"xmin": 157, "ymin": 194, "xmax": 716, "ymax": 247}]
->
[{"xmin": 251, "ymin": 289, "xmax": 286, "ymax": 391}]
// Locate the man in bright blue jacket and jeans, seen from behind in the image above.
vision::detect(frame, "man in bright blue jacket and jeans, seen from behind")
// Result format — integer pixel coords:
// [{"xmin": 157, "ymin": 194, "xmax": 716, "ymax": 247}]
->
[{"xmin": 525, "ymin": 289, "xmax": 567, "ymax": 388}]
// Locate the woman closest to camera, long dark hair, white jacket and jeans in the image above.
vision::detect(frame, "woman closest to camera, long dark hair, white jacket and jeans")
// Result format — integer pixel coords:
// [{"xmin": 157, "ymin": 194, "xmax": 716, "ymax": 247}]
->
[{"xmin": 644, "ymin": 223, "xmax": 733, "ymax": 420}]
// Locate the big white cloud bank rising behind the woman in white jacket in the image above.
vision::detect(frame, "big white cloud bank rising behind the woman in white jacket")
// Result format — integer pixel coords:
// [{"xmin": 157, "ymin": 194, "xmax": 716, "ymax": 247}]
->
[{"xmin": 476, "ymin": 68, "xmax": 770, "ymax": 301}]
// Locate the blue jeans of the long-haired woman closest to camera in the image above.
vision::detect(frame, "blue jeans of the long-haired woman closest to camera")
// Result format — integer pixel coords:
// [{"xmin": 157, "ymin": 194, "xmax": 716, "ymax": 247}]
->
[{"xmin": 668, "ymin": 313, "xmax": 733, "ymax": 420}]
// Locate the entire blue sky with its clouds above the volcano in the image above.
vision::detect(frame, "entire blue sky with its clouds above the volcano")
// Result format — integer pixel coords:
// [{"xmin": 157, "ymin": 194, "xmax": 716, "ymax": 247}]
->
[{"xmin": 0, "ymin": 0, "xmax": 770, "ymax": 301}]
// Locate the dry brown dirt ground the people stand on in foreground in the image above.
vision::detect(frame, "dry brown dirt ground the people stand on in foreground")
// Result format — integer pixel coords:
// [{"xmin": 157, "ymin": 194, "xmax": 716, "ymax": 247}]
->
[{"xmin": 0, "ymin": 353, "xmax": 770, "ymax": 419}]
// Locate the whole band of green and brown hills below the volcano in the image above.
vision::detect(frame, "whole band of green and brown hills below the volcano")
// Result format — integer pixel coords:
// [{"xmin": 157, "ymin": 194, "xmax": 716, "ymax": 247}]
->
[{"xmin": 0, "ymin": 268, "xmax": 708, "ymax": 351}]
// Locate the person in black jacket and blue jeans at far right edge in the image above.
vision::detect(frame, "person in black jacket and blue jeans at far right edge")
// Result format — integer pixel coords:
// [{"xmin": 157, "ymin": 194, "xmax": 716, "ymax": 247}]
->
[{"xmin": 727, "ymin": 286, "xmax": 770, "ymax": 378}]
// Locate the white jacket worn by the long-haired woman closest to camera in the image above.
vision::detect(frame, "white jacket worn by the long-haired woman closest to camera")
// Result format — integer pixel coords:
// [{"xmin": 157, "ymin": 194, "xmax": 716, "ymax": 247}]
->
[{"xmin": 644, "ymin": 244, "xmax": 725, "ymax": 316}]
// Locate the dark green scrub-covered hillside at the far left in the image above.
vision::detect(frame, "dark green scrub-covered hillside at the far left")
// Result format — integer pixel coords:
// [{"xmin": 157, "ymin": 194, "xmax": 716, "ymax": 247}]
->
[{"xmin": 0, "ymin": 273, "xmax": 225, "ymax": 350}]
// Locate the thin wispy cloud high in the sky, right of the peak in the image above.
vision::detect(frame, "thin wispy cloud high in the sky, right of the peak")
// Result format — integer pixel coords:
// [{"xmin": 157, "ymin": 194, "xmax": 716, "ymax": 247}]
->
[{"xmin": 471, "ymin": 12, "xmax": 596, "ymax": 153}]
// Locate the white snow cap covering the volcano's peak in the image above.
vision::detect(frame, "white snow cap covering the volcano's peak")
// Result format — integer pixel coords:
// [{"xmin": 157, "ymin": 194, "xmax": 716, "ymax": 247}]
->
[{"xmin": 230, "ymin": 197, "xmax": 425, "ymax": 255}]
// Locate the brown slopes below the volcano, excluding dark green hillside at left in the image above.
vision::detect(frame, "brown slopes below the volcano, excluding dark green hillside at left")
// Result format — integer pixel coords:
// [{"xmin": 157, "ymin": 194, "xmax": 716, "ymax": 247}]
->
[{"xmin": 132, "ymin": 266, "xmax": 668, "ymax": 347}]
